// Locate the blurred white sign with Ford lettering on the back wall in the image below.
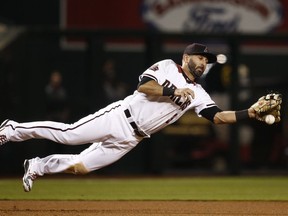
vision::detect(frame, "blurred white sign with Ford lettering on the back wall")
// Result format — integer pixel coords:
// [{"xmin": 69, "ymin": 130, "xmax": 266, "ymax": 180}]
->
[{"xmin": 142, "ymin": 0, "xmax": 283, "ymax": 33}]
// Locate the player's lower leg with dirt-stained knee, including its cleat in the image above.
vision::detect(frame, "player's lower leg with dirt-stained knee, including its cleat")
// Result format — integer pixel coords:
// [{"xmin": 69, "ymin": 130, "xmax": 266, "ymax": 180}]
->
[{"xmin": 23, "ymin": 137, "xmax": 141, "ymax": 192}]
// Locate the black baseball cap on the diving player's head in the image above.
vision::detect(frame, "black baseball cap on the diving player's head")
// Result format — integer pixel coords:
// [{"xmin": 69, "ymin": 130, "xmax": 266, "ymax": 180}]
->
[{"xmin": 184, "ymin": 43, "xmax": 217, "ymax": 63}]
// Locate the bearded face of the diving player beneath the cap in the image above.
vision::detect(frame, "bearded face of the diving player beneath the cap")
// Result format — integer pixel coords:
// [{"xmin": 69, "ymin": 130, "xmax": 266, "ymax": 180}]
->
[{"xmin": 187, "ymin": 55, "xmax": 208, "ymax": 78}]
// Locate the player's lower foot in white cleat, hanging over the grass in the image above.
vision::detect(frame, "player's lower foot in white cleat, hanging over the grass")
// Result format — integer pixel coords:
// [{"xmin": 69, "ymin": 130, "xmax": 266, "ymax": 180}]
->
[{"xmin": 23, "ymin": 158, "xmax": 37, "ymax": 192}]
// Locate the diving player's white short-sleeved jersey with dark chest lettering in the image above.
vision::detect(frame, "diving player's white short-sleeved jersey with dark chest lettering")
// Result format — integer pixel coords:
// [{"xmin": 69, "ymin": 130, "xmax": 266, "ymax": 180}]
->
[{"xmin": 124, "ymin": 60, "xmax": 215, "ymax": 135}]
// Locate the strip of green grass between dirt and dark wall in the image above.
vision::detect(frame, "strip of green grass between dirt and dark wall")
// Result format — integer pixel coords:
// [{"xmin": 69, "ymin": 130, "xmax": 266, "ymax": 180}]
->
[{"xmin": 0, "ymin": 176, "xmax": 288, "ymax": 201}]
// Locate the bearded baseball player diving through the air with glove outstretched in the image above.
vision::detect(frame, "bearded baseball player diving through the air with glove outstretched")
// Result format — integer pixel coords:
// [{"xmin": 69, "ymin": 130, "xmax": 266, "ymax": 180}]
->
[{"xmin": 0, "ymin": 43, "xmax": 281, "ymax": 192}]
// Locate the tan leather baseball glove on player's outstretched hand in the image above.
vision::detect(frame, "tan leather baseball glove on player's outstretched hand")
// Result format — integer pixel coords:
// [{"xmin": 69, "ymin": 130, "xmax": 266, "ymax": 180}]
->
[{"xmin": 251, "ymin": 93, "xmax": 282, "ymax": 122}]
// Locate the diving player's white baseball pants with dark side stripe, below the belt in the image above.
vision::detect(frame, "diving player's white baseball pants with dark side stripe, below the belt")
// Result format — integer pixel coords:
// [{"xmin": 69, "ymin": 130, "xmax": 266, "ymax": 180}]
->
[{"xmin": 6, "ymin": 101, "xmax": 143, "ymax": 176}]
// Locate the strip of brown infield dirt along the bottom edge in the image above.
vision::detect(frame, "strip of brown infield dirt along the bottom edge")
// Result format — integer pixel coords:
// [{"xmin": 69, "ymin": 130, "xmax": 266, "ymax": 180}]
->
[{"xmin": 0, "ymin": 201, "xmax": 288, "ymax": 216}]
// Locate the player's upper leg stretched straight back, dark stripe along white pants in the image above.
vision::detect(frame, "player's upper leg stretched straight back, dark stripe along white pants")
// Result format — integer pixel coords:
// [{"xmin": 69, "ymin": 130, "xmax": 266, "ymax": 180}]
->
[{"xmin": 0, "ymin": 103, "xmax": 124, "ymax": 145}]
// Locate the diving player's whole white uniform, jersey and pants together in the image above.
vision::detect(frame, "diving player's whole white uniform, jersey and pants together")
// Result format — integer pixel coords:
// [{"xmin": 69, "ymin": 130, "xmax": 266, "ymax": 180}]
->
[{"xmin": 0, "ymin": 60, "xmax": 215, "ymax": 175}]
